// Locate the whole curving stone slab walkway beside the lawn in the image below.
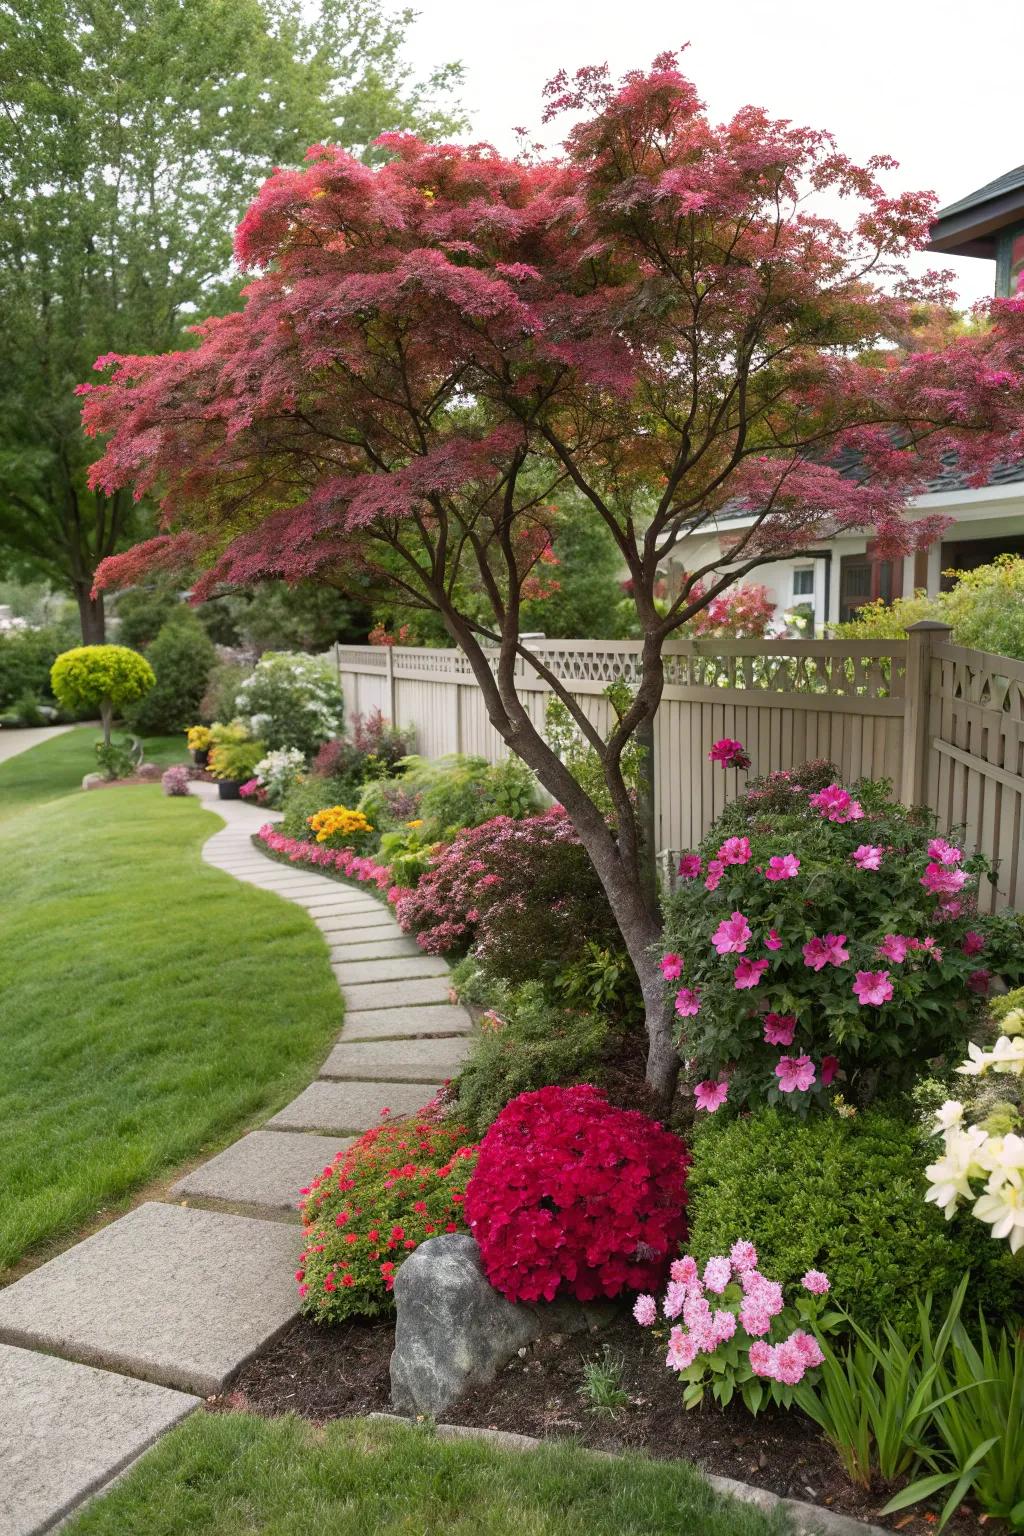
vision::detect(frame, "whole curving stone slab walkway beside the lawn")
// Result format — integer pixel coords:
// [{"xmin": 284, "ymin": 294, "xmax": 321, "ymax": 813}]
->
[{"xmin": 0, "ymin": 786, "xmax": 471, "ymax": 1536}]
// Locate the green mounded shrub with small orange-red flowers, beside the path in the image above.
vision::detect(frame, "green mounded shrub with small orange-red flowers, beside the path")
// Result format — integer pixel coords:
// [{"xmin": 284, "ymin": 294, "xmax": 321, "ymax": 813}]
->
[{"xmin": 295, "ymin": 1111, "xmax": 476, "ymax": 1322}]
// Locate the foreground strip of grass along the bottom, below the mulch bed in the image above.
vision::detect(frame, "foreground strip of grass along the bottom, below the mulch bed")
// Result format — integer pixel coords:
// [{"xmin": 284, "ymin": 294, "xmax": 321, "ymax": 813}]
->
[{"xmin": 68, "ymin": 1412, "xmax": 791, "ymax": 1536}]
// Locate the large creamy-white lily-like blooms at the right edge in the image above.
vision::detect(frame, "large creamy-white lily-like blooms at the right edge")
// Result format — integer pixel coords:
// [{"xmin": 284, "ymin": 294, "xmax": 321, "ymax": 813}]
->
[{"xmin": 924, "ymin": 1006, "xmax": 1024, "ymax": 1253}]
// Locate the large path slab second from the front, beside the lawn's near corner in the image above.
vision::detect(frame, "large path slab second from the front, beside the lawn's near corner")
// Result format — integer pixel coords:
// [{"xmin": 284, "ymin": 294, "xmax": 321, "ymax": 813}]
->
[{"xmin": 0, "ymin": 1201, "xmax": 301, "ymax": 1396}]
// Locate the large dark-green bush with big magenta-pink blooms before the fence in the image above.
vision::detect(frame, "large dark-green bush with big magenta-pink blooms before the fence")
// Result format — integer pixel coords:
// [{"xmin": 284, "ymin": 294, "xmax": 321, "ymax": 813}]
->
[{"xmin": 663, "ymin": 758, "xmax": 1024, "ymax": 1114}]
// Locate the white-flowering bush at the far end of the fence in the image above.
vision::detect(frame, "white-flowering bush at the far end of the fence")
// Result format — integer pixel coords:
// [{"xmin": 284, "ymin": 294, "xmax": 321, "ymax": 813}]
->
[{"xmin": 235, "ymin": 651, "xmax": 344, "ymax": 757}]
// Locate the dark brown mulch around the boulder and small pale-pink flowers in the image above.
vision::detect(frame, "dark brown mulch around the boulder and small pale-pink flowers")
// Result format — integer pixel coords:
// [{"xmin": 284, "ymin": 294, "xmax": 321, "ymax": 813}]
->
[{"xmin": 207, "ymin": 1318, "xmax": 988, "ymax": 1536}]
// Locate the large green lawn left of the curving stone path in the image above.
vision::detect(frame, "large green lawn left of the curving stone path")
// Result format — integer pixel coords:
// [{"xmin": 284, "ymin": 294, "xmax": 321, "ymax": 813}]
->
[{"xmin": 0, "ymin": 786, "xmax": 342, "ymax": 1265}]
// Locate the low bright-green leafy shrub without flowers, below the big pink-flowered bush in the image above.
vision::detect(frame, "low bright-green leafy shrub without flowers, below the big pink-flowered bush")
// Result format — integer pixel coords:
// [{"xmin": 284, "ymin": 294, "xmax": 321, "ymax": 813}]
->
[{"xmin": 688, "ymin": 1109, "xmax": 1024, "ymax": 1329}]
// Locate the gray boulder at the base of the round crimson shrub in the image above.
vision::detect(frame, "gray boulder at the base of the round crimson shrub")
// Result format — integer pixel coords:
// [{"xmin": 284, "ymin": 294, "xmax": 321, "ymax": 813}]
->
[{"xmin": 391, "ymin": 1232, "xmax": 614, "ymax": 1416}]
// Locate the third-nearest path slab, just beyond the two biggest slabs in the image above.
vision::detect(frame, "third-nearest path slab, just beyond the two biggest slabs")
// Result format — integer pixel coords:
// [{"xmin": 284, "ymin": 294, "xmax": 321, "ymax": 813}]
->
[{"xmin": 170, "ymin": 1130, "xmax": 350, "ymax": 1210}]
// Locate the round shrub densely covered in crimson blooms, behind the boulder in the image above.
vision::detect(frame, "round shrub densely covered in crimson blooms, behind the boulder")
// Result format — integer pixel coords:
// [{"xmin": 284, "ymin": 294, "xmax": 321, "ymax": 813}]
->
[{"xmin": 465, "ymin": 1083, "xmax": 689, "ymax": 1301}]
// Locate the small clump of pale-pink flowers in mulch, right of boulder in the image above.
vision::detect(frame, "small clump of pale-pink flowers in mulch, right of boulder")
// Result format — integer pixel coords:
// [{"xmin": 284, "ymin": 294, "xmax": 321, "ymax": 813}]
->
[{"xmin": 633, "ymin": 1240, "xmax": 840, "ymax": 1413}]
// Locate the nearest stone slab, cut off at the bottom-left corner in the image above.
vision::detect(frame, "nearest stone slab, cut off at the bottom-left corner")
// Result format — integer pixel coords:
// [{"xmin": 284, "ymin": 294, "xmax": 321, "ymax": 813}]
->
[{"xmin": 0, "ymin": 1344, "xmax": 200, "ymax": 1536}]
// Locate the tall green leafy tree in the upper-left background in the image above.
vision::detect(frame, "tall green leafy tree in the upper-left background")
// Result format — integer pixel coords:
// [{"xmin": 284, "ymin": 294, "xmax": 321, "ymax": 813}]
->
[{"xmin": 0, "ymin": 0, "xmax": 459, "ymax": 642}]
